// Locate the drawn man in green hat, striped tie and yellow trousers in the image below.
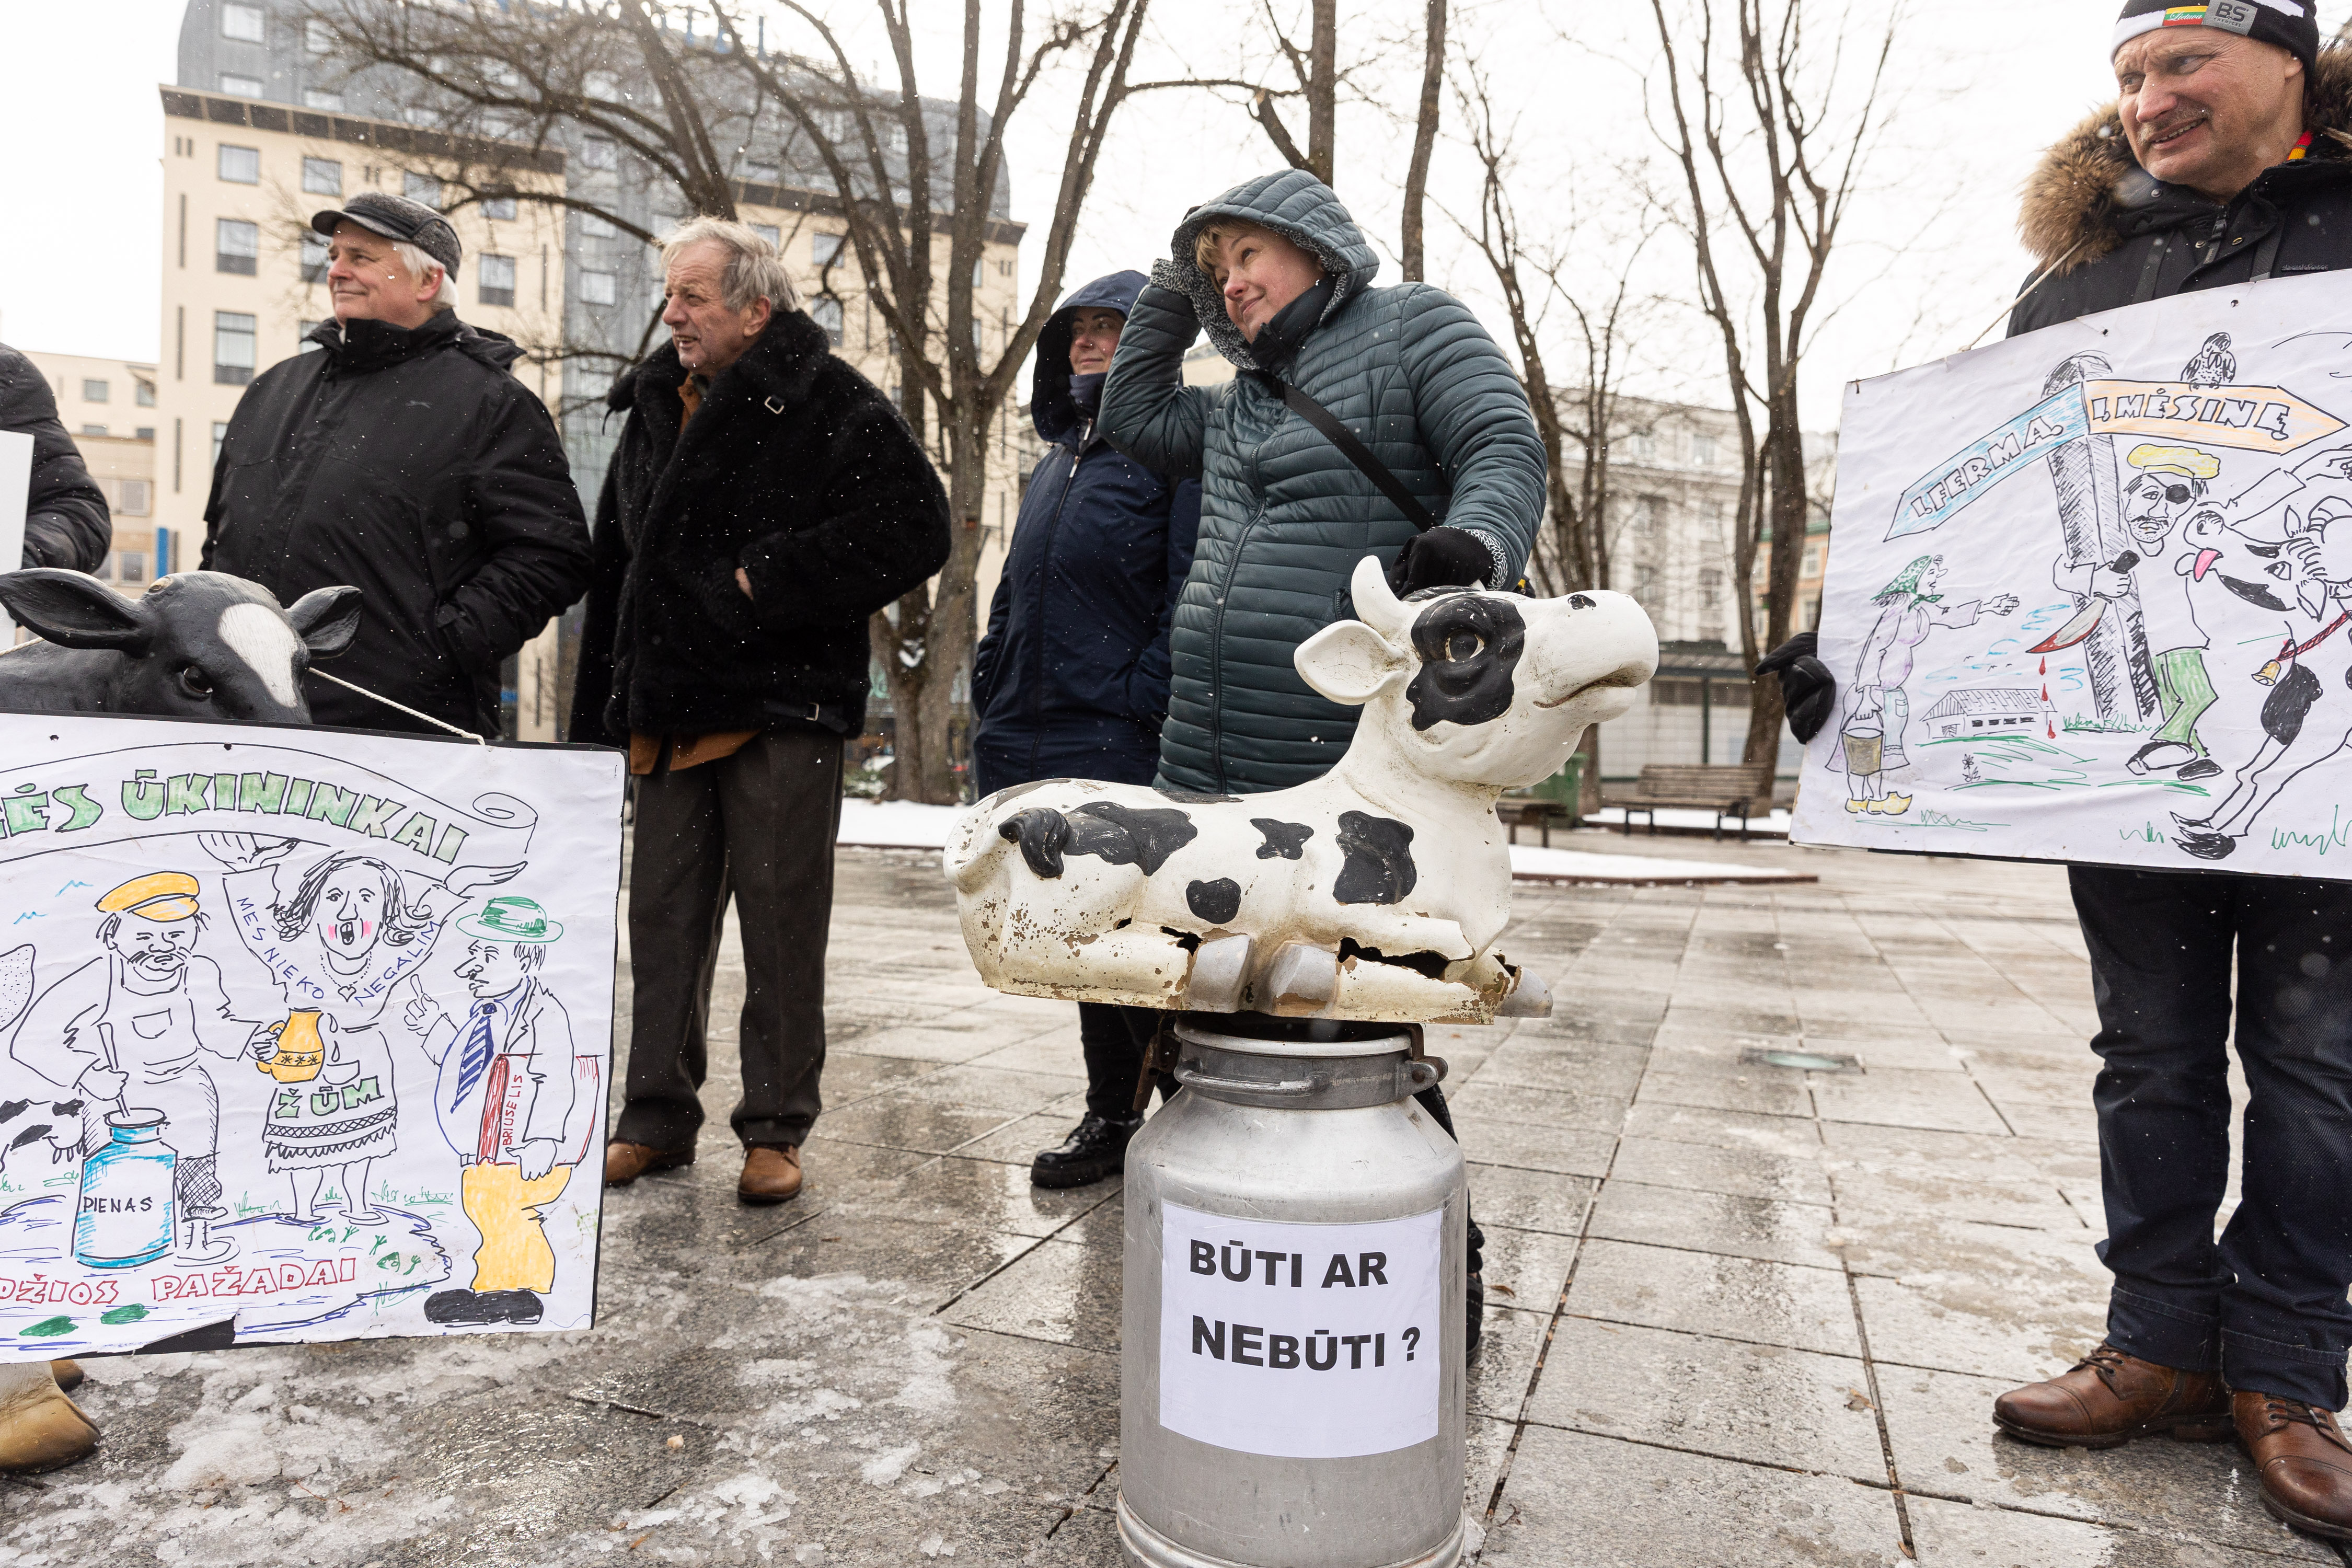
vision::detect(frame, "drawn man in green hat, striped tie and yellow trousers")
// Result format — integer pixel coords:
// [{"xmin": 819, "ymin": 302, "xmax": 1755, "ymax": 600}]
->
[{"xmin": 405, "ymin": 898, "xmax": 579, "ymax": 1326}]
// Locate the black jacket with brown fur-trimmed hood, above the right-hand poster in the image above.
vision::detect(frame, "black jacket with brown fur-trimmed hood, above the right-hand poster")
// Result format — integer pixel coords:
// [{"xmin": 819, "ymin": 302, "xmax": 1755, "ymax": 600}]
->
[{"xmin": 2009, "ymin": 44, "xmax": 2352, "ymax": 336}]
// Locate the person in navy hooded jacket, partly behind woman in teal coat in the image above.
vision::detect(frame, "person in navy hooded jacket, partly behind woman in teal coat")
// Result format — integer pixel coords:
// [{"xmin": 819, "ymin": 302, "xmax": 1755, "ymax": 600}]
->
[{"xmin": 972, "ymin": 273, "xmax": 1200, "ymax": 1187}]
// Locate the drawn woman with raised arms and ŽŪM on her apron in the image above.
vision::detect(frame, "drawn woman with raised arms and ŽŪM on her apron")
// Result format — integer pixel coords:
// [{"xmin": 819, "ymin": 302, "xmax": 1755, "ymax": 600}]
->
[{"xmin": 198, "ymin": 832, "xmax": 522, "ymax": 1225}]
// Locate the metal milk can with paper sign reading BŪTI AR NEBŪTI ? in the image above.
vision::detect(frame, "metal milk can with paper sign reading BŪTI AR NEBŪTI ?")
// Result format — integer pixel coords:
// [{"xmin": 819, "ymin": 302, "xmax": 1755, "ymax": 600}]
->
[{"xmin": 1120, "ymin": 1013, "xmax": 1468, "ymax": 1568}]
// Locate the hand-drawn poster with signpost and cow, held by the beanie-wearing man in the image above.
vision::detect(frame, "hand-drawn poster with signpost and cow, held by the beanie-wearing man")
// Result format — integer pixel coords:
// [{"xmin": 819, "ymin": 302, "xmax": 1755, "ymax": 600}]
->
[{"xmin": 1795, "ymin": 278, "xmax": 2352, "ymax": 877}]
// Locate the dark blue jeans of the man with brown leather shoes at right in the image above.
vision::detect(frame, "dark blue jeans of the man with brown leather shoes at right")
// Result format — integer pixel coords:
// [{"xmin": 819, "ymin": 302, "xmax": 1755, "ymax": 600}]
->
[{"xmin": 2070, "ymin": 865, "xmax": 2352, "ymax": 1411}]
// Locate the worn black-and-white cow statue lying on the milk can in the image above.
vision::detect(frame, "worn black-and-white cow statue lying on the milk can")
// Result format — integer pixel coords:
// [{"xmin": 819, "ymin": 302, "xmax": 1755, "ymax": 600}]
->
[{"xmin": 943, "ymin": 557, "xmax": 1658, "ymax": 1023}]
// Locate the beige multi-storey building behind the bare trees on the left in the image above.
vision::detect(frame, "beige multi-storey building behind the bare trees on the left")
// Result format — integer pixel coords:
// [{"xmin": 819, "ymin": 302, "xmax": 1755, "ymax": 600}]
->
[{"xmin": 158, "ymin": 0, "xmax": 1023, "ymax": 727}]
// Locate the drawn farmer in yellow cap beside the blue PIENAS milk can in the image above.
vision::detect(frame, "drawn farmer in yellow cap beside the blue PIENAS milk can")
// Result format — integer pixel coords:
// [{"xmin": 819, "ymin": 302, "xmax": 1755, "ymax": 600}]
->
[{"xmin": 9, "ymin": 872, "xmax": 266, "ymax": 1262}]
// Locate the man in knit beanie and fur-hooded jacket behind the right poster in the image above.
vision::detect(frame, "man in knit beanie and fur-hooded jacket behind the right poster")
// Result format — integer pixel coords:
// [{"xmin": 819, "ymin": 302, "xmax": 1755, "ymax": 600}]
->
[{"xmin": 1764, "ymin": 0, "xmax": 2352, "ymax": 1540}]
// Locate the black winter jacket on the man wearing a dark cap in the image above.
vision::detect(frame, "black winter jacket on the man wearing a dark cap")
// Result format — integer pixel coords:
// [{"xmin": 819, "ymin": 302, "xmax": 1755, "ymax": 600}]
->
[{"xmin": 202, "ymin": 313, "xmax": 588, "ymax": 733}]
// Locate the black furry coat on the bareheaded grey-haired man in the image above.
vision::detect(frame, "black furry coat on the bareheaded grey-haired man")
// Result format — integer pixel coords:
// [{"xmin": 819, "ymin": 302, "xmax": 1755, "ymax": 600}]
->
[{"xmin": 572, "ymin": 310, "xmax": 948, "ymax": 745}]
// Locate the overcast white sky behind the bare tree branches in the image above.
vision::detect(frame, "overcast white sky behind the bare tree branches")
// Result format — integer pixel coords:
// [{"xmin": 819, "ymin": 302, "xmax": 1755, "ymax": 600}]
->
[{"xmin": 0, "ymin": 0, "xmax": 2277, "ymax": 428}]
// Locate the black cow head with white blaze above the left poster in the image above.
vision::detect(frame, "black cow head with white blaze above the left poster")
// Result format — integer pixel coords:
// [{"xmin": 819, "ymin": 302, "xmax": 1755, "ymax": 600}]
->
[{"xmin": 0, "ymin": 567, "xmax": 360, "ymax": 724}]
